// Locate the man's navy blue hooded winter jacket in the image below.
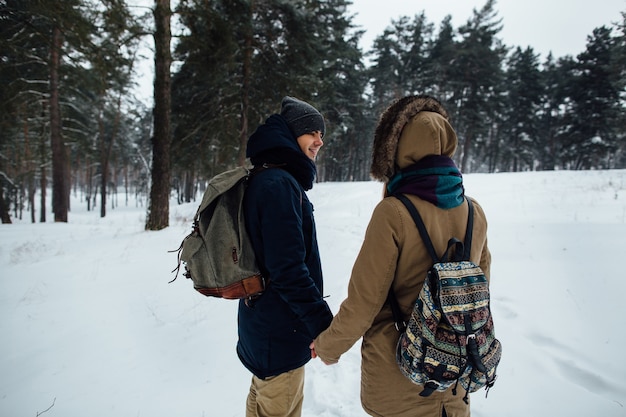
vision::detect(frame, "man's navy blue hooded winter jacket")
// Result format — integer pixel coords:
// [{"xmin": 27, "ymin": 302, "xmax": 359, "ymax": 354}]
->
[{"xmin": 237, "ymin": 115, "xmax": 332, "ymax": 378}]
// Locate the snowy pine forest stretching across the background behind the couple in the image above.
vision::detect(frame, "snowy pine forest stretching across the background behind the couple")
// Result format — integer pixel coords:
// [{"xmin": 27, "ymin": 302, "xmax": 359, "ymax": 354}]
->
[{"xmin": 0, "ymin": 0, "xmax": 626, "ymax": 230}]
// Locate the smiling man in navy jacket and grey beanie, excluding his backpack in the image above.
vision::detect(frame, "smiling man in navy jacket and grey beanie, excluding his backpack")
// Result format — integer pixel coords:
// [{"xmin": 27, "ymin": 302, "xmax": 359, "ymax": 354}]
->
[{"xmin": 237, "ymin": 97, "xmax": 332, "ymax": 417}]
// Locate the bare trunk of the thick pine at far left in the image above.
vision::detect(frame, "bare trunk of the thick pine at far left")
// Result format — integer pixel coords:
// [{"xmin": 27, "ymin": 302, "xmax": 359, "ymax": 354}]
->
[{"xmin": 49, "ymin": 27, "xmax": 69, "ymax": 223}]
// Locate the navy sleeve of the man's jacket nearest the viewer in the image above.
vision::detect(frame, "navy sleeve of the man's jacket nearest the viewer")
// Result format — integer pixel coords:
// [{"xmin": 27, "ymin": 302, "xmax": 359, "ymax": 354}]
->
[{"xmin": 256, "ymin": 177, "xmax": 332, "ymax": 340}]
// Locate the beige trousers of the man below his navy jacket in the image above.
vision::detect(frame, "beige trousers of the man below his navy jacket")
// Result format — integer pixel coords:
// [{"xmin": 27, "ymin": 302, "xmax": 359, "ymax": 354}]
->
[{"xmin": 246, "ymin": 366, "xmax": 304, "ymax": 417}]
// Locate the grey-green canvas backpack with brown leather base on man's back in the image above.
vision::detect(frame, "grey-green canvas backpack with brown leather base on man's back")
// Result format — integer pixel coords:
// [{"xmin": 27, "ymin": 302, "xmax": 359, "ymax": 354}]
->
[{"xmin": 170, "ymin": 167, "xmax": 265, "ymax": 299}]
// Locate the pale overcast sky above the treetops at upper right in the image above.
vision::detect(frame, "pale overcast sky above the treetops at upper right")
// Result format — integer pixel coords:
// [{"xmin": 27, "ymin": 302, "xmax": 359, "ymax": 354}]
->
[{"xmin": 348, "ymin": 0, "xmax": 626, "ymax": 58}]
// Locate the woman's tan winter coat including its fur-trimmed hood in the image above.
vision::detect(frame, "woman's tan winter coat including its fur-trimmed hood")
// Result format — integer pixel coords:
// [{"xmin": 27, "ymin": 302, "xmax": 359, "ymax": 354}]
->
[{"xmin": 315, "ymin": 97, "xmax": 491, "ymax": 417}]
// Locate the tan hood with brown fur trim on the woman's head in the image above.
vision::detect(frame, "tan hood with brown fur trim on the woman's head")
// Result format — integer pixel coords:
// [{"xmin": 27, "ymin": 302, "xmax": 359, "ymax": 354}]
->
[{"xmin": 371, "ymin": 95, "xmax": 458, "ymax": 182}]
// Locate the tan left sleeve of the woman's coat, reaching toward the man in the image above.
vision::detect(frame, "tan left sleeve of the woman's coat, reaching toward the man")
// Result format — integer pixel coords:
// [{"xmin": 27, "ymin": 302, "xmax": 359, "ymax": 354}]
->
[{"xmin": 315, "ymin": 200, "xmax": 404, "ymax": 363}]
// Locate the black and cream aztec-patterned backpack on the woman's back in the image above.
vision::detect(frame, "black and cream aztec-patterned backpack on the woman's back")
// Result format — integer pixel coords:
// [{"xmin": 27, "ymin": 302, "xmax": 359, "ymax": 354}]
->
[{"xmin": 389, "ymin": 195, "xmax": 502, "ymax": 402}]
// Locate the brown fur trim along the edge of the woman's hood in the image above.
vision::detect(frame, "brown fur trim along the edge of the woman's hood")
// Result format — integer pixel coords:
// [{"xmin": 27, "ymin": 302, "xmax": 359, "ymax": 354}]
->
[{"xmin": 371, "ymin": 95, "xmax": 448, "ymax": 182}]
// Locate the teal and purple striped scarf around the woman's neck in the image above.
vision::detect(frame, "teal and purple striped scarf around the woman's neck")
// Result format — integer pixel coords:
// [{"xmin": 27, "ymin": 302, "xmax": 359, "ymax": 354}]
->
[{"xmin": 387, "ymin": 155, "xmax": 465, "ymax": 209}]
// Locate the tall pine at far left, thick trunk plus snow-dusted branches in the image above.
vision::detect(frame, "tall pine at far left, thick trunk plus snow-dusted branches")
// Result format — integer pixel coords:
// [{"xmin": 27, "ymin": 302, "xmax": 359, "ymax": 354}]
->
[{"xmin": 0, "ymin": 0, "xmax": 91, "ymax": 222}]
